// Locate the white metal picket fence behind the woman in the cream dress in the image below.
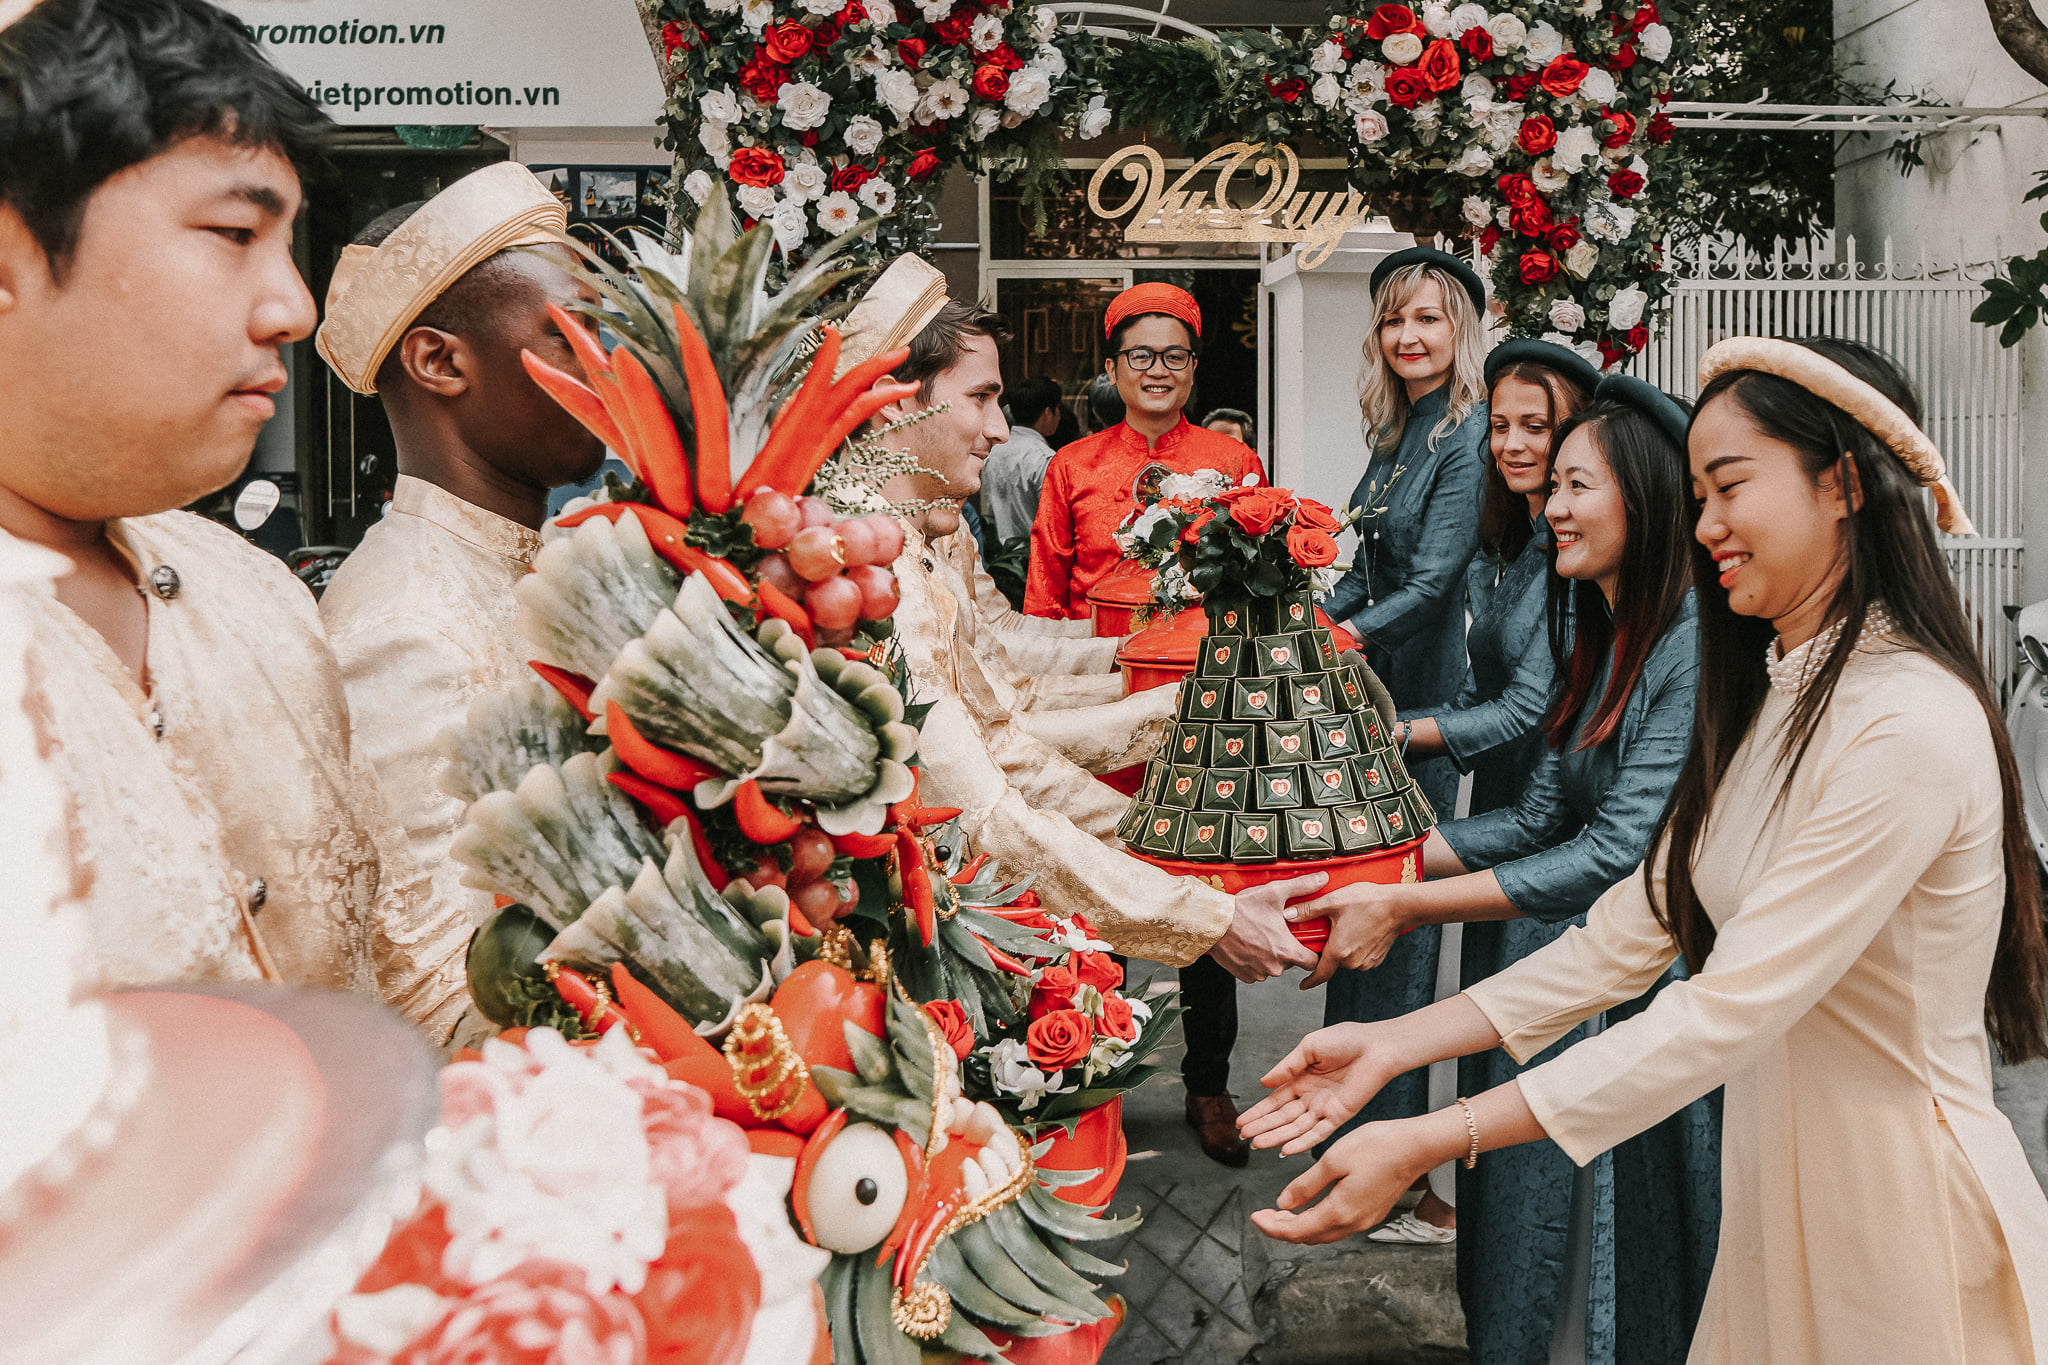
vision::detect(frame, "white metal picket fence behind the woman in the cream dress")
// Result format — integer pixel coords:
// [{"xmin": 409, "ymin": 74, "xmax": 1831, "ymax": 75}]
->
[{"xmin": 1630, "ymin": 237, "xmax": 2028, "ymax": 688}]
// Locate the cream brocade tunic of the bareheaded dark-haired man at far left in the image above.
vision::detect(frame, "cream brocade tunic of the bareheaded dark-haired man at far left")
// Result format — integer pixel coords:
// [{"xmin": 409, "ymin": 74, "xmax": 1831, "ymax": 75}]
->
[{"xmin": 29, "ymin": 512, "xmax": 436, "ymax": 1021}]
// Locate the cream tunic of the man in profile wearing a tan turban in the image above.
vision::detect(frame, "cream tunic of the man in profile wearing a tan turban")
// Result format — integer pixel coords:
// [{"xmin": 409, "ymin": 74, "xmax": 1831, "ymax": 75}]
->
[{"xmin": 319, "ymin": 475, "xmax": 541, "ymax": 1036}]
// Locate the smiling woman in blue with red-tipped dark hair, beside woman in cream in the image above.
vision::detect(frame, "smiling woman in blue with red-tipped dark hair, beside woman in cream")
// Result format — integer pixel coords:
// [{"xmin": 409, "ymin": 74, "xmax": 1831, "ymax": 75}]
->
[{"xmin": 1298, "ymin": 377, "xmax": 1720, "ymax": 1365}]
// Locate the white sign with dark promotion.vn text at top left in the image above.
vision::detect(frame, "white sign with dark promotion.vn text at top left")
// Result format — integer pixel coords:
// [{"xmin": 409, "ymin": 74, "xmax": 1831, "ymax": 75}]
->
[{"xmin": 215, "ymin": 0, "xmax": 662, "ymax": 129}]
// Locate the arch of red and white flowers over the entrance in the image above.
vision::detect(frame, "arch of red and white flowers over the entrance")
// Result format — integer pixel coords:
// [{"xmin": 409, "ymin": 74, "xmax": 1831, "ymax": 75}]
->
[{"xmin": 657, "ymin": 0, "xmax": 1679, "ymax": 366}]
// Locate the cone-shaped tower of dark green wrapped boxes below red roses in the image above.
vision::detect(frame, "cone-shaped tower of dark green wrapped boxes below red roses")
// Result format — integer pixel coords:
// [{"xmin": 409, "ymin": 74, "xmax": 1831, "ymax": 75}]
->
[{"xmin": 1116, "ymin": 593, "xmax": 1436, "ymax": 864}]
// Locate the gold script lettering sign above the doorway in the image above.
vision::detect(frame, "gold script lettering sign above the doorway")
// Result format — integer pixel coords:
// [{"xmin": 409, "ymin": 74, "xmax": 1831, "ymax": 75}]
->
[{"xmin": 1087, "ymin": 141, "xmax": 1368, "ymax": 270}]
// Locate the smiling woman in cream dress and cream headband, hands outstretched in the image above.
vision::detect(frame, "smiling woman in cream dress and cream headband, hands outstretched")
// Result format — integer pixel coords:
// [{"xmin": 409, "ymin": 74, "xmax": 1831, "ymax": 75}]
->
[{"xmin": 1245, "ymin": 338, "xmax": 2048, "ymax": 1365}]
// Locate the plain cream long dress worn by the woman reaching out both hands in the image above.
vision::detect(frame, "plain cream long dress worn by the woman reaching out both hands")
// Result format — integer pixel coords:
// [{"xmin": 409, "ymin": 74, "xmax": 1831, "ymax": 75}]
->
[{"xmin": 1466, "ymin": 641, "xmax": 2048, "ymax": 1365}]
